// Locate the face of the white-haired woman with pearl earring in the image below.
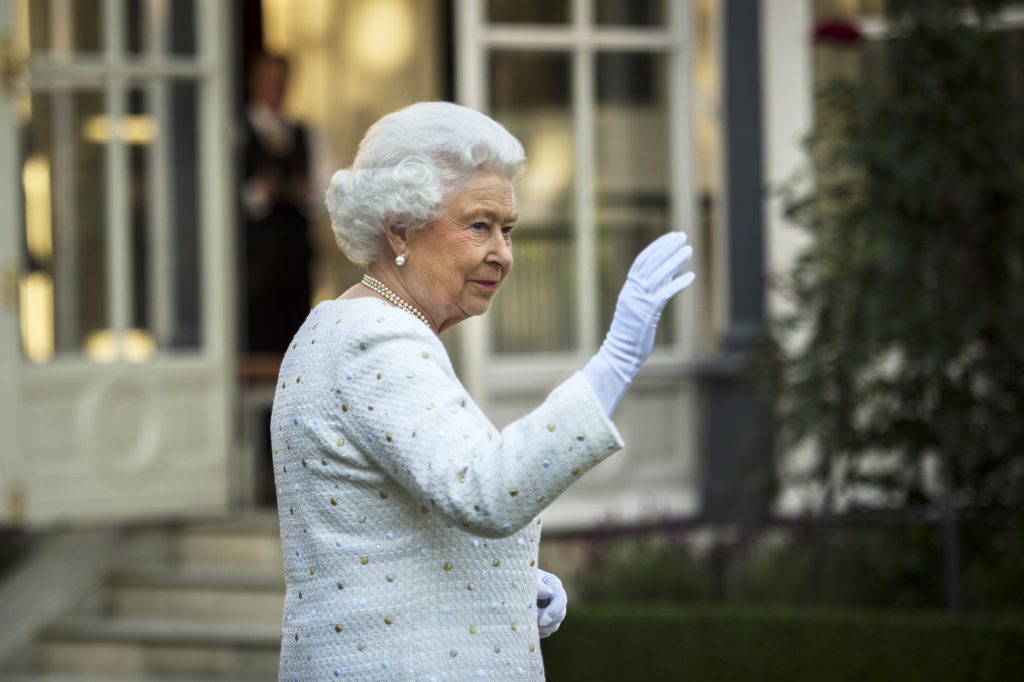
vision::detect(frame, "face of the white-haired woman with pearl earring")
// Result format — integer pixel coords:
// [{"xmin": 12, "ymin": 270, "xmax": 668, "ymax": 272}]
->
[{"xmin": 399, "ymin": 171, "xmax": 518, "ymax": 331}]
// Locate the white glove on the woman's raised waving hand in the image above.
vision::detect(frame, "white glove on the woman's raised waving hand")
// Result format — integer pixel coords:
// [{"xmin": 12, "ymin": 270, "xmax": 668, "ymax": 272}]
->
[{"xmin": 583, "ymin": 232, "xmax": 695, "ymax": 417}]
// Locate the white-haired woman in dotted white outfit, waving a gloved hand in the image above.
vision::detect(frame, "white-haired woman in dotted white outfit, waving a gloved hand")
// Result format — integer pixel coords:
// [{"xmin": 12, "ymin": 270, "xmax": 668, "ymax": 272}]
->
[{"xmin": 271, "ymin": 102, "xmax": 693, "ymax": 682}]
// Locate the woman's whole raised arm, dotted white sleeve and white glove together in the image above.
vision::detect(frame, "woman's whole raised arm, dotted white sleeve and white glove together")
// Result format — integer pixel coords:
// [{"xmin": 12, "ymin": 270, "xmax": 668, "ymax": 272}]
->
[{"xmin": 332, "ymin": 232, "xmax": 693, "ymax": 537}]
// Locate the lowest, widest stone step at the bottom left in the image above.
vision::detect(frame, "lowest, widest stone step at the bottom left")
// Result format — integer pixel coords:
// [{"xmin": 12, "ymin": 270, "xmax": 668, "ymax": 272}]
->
[{"xmin": 33, "ymin": 617, "xmax": 281, "ymax": 680}]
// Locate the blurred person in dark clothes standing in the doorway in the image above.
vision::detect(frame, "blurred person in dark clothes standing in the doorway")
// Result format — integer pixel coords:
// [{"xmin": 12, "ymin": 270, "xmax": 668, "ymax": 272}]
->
[{"xmin": 242, "ymin": 53, "xmax": 311, "ymax": 354}]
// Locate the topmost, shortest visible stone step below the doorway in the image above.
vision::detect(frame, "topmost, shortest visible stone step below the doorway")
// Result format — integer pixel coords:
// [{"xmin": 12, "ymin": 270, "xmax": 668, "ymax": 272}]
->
[{"xmin": 173, "ymin": 512, "xmax": 284, "ymax": 576}]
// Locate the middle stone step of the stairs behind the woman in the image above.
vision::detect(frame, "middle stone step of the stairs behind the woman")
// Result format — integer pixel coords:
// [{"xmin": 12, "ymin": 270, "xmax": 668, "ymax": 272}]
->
[{"xmin": 102, "ymin": 566, "xmax": 285, "ymax": 627}]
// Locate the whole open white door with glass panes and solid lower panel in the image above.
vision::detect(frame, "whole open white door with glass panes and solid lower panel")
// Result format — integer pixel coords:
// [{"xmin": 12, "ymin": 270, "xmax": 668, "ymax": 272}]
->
[{"xmin": 0, "ymin": 0, "xmax": 233, "ymax": 524}]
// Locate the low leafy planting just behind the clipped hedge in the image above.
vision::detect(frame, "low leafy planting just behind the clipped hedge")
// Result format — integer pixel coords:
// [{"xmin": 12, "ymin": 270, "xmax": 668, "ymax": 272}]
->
[{"xmin": 569, "ymin": 522, "xmax": 1024, "ymax": 614}]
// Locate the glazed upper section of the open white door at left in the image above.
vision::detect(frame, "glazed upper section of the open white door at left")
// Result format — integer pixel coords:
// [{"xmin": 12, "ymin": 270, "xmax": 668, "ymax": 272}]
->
[{"xmin": 14, "ymin": 0, "xmax": 209, "ymax": 363}]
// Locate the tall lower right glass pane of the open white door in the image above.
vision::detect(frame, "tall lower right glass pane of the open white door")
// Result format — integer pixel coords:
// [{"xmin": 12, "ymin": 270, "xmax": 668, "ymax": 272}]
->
[{"xmin": 123, "ymin": 80, "xmax": 200, "ymax": 361}]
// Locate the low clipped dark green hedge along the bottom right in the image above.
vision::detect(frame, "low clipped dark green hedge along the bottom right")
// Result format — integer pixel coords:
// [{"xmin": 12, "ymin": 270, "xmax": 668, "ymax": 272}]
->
[{"xmin": 543, "ymin": 605, "xmax": 1024, "ymax": 682}]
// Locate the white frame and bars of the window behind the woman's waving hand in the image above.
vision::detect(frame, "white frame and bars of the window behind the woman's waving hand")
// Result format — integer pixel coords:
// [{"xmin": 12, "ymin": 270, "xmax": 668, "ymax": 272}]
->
[{"xmin": 456, "ymin": 0, "xmax": 700, "ymax": 400}]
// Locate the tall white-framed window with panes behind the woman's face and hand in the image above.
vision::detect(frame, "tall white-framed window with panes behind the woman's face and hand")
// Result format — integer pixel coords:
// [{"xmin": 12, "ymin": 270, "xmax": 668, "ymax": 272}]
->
[{"xmin": 458, "ymin": 0, "xmax": 701, "ymax": 372}]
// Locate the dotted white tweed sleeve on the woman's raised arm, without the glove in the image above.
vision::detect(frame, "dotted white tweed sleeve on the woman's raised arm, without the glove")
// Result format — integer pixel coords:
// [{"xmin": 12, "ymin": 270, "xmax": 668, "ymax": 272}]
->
[{"xmin": 331, "ymin": 310, "xmax": 623, "ymax": 537}]
